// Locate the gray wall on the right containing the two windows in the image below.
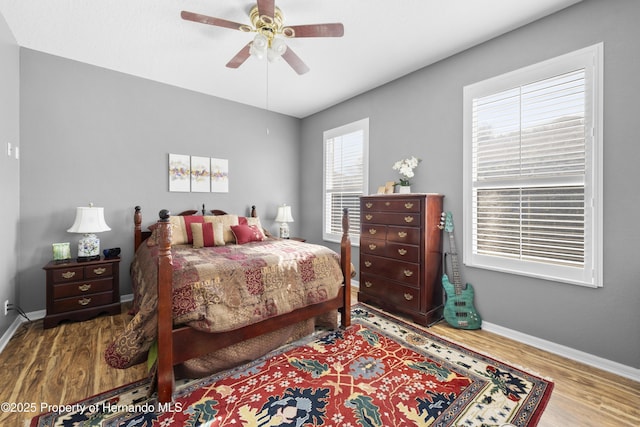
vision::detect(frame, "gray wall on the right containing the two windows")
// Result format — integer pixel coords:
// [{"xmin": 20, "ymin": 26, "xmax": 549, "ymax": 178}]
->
[{"xmin": 301, "ymin": 0, "xmax": 640, "ymax": 368}]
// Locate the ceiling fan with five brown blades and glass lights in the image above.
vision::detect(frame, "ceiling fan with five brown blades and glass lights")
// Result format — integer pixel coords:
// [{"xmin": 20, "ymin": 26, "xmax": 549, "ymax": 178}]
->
[{"xmin": 180, "ymin": 0, "xmax": 344, "ymax": 74}]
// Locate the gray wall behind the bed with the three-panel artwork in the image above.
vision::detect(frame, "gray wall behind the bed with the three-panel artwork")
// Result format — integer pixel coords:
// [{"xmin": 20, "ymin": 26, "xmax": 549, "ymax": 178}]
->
[{"xmin": 17, "ymin": 49, "xmax": 300, "ymax": 311}]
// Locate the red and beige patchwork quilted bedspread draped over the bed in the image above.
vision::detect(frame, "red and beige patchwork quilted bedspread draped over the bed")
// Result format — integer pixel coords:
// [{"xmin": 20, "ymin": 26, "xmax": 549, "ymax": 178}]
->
[{"xmin": 105, "ymin": 239, "xmax": 343, "ymax": 368}]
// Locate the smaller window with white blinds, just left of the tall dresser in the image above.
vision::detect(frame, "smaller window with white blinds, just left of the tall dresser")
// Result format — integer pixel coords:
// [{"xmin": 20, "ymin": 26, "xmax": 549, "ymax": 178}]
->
[{"xmin": 322, "ymin": 119, "xmax": 369, "ymax": 245}]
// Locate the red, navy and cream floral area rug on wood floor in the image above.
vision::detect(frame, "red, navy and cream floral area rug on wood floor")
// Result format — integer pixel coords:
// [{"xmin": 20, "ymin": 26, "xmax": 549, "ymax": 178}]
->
[{"xmin": 31, "ymin": 304, "xmax": 553, "ymax": 427}]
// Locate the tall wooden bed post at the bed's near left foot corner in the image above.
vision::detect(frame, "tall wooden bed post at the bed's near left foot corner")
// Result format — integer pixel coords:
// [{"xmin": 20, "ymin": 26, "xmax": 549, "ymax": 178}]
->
[{"xmin": 157, "ymin": 209, "xmax": 174, "ymax": 403}]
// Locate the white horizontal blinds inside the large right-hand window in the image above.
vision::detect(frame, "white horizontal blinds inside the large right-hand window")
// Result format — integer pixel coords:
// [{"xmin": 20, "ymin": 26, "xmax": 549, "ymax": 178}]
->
[{"xmin": 471, "ymin": 69, "xmax": 586, "ymax": 267}]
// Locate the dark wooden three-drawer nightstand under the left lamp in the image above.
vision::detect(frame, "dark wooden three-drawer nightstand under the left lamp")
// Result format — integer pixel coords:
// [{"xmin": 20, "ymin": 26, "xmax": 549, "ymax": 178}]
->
[{"xmin": 43, "ymin": 258, "xmax": 120, "ymax": 329}]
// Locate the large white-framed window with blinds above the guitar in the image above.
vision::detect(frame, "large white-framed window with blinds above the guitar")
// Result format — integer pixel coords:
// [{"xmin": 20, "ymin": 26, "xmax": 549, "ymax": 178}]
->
[{"xmin": 464, "ymin": 44, "xmax": 603, "ymax": 287}]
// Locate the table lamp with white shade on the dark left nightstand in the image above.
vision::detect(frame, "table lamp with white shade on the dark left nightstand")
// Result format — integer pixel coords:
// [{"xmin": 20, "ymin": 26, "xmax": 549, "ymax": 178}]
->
[{"xmin": 67, "ymin": 203, "xmax": 111, "ymax": 262}]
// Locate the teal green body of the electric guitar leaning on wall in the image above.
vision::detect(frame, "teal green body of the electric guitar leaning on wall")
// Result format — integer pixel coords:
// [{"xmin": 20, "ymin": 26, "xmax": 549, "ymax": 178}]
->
[{"xmin": 442, "ymin": 274, "xmax": 482, "ymax": 329}]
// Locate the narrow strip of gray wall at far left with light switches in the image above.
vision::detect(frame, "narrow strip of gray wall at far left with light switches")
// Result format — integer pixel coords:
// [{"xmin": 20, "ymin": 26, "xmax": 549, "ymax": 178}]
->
[{"xmin": 0, "ymin": 15, "xmax": 20, "ymax": 335}]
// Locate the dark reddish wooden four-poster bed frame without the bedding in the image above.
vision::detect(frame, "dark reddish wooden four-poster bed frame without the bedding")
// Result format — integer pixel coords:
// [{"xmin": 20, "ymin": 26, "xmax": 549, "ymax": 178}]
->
[{"xmin": 129, "ymin": 206, "xmax": 352, "ymax": 403}]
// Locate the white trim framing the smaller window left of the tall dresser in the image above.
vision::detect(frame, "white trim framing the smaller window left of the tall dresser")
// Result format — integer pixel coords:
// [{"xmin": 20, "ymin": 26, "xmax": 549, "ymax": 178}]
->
[{"xmin": 322, "ymin": 117, "xmax": 369, "ymax": 246}]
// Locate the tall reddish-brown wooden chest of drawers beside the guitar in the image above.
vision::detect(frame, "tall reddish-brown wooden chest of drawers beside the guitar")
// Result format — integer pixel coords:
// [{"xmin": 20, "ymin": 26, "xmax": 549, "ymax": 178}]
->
[{"xmin": 358, "ymin": 194, "xmax": 444, "ymax": 325}]
